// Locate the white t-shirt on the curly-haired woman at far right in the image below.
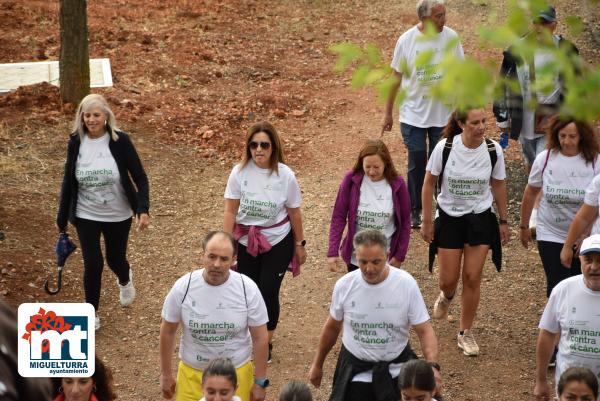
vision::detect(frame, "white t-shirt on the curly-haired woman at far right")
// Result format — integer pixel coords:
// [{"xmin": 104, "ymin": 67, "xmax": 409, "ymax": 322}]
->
[{"xmin": 528, "ymin": 150, "xmax": 600, "ymax": 244}]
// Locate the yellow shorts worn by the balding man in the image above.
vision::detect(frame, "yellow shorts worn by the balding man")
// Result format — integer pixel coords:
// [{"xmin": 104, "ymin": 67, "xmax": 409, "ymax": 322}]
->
[{"xmin": 175, "ymin": 361, "xmax": 254, "ymax": 401}]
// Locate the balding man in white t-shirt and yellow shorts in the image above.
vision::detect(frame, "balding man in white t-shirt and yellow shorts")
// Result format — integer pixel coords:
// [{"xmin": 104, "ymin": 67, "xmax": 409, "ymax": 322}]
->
[{"xmin": 160, "ymin": 231, "xmax": 269, "ymax": 401}]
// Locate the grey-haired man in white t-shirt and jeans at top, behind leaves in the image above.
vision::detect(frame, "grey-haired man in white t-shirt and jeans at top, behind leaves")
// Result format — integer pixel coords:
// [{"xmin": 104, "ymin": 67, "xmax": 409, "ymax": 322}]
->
[{"xmin": 382, "ymin": 0, "xmax": 465, "ymax": 228}]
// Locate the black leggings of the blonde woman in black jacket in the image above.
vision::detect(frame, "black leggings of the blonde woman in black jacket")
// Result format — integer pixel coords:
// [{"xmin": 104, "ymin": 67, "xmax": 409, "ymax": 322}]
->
[{"xmin": 75, "ymin": 218, "xmax": 131, "ymax": 311}]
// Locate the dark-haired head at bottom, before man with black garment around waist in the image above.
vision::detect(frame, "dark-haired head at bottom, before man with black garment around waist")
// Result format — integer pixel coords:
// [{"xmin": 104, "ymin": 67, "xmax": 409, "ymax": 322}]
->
[{"xmin": 398, "ymin": 359, "xmax": 435, "ymax": 401}]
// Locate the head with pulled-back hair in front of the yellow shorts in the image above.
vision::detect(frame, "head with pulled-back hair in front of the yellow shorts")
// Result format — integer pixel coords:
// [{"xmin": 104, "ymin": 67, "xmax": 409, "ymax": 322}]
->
[{"xmin": 202, "ymin": 358, "xmax": 237, "ymax": 401}]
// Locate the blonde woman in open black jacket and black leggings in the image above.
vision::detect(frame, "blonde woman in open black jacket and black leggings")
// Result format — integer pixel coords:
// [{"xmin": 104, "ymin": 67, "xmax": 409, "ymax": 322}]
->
[{"xmin": 56, "ymin": 94, "xmax": 150, "ymax": 329}]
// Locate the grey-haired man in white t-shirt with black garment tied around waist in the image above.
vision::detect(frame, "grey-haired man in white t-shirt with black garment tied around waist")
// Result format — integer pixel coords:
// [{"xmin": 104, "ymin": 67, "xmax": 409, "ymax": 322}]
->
[{"xmin": 309, "ymin": 229, "xmax": 441, "ymax": 401}]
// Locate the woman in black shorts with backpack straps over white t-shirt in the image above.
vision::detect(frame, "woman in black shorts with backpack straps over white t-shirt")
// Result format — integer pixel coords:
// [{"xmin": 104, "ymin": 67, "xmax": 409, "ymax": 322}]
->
[{"xmin": 421, "ymin": 108, "xmax": 509, "ymax": 356}]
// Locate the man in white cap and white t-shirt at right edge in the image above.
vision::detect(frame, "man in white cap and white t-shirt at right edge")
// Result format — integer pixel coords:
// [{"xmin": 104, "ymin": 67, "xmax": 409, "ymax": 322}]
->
[{"xmin": 534, "ymin": 234, "xmax": 600, "ymax": 401}]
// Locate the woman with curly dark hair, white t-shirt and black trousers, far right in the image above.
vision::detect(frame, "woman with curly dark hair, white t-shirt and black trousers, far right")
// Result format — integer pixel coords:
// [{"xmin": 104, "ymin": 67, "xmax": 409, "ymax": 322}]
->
[{"xmin": 520, "ymin": 116, "xmax": 600, "ymax": 297}]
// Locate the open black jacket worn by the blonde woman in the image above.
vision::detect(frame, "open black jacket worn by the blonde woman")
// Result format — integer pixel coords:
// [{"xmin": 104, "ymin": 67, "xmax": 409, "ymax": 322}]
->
[{"xmin": 56, "ymin": 131, "xmax": 150, "ymax": 231}]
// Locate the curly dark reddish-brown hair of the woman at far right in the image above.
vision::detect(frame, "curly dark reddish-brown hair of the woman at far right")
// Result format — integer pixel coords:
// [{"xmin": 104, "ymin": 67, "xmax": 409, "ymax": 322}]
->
[{"xmin": 546, "ymin": 115, "xmax": 600, "ymax": 163}]
